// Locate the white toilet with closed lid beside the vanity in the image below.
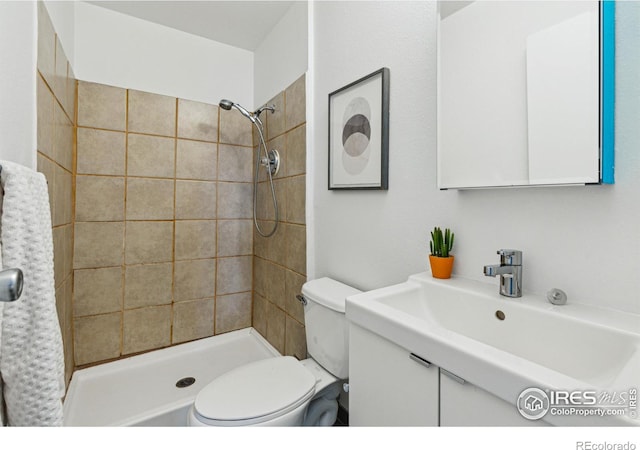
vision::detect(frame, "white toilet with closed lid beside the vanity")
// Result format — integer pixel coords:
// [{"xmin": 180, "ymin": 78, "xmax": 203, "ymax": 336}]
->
[{"xmin": 189, "ymin": 278, "xmax": 361, "ymax": 427}]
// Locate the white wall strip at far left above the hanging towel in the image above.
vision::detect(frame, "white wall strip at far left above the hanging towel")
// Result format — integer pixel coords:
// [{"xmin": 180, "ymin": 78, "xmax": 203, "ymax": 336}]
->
[{"xmin": 0, "ymin": 1, "xmax": 37, "ymax": 169}]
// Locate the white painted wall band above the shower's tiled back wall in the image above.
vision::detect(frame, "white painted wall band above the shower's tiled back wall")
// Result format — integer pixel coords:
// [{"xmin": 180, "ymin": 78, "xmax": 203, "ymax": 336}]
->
[{"xmin": 74, "ymin": 2, "xmax": 253, "ymax": 105}]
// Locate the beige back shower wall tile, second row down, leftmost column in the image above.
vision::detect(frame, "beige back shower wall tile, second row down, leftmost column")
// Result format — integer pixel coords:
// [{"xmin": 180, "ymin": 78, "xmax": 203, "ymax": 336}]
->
[{"xmin": 77, "ymin": 128, "xmax": 126, "ymax": 175}]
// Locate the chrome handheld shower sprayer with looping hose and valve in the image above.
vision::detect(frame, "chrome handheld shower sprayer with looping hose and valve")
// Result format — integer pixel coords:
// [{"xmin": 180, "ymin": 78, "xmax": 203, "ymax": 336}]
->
[{"xmin": 219, "ymin": 99, "xmax": 280, "ymax": 237}]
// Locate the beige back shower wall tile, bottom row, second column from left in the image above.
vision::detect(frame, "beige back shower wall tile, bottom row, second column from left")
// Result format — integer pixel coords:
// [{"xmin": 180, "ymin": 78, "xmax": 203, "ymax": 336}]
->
[{"xmin": 122, "ymin": 305, "xmax": 171, "ymax": 355}]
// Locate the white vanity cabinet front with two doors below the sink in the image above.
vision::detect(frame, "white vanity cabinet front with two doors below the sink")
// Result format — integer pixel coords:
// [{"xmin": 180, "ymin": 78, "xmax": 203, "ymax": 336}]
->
[{"xmin": 349, "ymin": 323, "xmax": 548, "ymax": 426}]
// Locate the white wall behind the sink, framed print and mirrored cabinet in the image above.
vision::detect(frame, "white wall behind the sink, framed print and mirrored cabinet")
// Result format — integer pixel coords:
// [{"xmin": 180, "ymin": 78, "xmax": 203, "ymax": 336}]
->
[{"xmin": 308, "ymin": 1, "xmax": 640, "ymax": 313}]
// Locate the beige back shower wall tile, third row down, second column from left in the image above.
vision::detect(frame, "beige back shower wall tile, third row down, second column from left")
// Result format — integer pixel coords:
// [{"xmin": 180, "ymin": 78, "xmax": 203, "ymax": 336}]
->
[{"xmin": 127, "ymin": 177, "xmax": 174, "ymax": 220}]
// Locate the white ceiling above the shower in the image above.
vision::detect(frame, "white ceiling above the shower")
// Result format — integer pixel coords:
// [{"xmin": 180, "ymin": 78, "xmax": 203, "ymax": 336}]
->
[{"xmin": 87, "ymin": 0, "xmax": 294, "ymax": 51}]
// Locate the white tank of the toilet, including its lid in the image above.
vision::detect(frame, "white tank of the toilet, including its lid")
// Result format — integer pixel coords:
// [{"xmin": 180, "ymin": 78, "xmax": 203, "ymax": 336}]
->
[{"xmin": 302, "ymin": 278, "xmax": 362, "ymax": 379}]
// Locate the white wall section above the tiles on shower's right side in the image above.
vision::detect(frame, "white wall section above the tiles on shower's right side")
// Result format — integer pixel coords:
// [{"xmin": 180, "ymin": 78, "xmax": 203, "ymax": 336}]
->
[{"xmin": 253, "ymin": 1, "xmax": 308, "ymax": 107}]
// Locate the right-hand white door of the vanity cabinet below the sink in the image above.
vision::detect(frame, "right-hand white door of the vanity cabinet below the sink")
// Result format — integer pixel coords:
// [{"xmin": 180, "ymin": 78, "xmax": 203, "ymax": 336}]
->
[{"xmin": 440, "ymin": 371, "xmax": 548, "ymax": 427}]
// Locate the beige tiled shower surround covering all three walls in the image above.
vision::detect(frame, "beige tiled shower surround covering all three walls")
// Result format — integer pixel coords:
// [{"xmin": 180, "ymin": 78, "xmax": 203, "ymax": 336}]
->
[{"xmin": 38, "ymin": 4, "xmax": 306, "ymax": 381}]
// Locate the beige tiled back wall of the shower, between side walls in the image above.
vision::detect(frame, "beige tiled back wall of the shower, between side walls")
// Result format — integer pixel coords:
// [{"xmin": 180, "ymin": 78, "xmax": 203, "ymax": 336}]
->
[{"xmin": 73, "ymin": 81, "xmax": 252, "ymax": 365}]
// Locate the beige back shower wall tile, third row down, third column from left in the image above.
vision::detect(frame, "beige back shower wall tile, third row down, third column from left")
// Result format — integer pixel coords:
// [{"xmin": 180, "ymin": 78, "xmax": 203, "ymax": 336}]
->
[{"xmin": 176, "ymin": 180, "xmax": 216, "ymax": 219}]
